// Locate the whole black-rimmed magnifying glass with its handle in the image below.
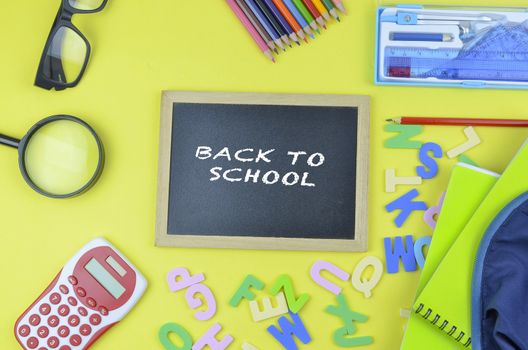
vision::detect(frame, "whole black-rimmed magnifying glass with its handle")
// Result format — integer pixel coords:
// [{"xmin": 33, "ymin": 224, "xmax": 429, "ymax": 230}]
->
[{"xmin": 0, "ymin": 115, "xmax": 104, "ymax": 198}]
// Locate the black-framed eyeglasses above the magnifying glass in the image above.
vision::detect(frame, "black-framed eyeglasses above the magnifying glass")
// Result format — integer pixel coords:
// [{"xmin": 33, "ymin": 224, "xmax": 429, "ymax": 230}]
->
[{"xmin": 35, "ymin": 0, "xmax": 108, "ymax": 90}]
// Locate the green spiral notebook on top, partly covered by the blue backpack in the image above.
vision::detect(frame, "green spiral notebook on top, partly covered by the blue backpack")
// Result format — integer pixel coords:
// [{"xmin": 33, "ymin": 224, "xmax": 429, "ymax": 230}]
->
[{"xmin": 413, "ymin": 142, "xmax": 528, "ymax": 348}]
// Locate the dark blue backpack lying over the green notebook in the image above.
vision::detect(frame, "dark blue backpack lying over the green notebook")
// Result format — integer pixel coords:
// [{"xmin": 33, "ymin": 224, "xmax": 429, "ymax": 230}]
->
[{"xmin": 471, "ymin": 193, "xmax": 528, "ymax": 350}]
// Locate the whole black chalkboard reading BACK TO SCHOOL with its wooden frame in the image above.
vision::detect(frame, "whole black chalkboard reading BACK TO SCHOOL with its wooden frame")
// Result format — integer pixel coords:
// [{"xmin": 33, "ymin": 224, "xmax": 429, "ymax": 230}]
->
[{"xmin": 158, "ymin": 93, "xmax": 368, "ymax": 250}]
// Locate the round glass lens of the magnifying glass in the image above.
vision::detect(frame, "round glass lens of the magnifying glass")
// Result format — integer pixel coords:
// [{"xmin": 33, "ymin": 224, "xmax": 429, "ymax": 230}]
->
[{"xmin": 24, "ymin": 120, "xmax": 100, "ymax": 196}]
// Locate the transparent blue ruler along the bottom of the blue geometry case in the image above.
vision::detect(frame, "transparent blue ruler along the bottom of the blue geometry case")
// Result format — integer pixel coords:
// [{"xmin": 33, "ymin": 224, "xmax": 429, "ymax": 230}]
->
[{"xmin": 385, "ymin": 47, "xmax": 528, "ymax": 82}]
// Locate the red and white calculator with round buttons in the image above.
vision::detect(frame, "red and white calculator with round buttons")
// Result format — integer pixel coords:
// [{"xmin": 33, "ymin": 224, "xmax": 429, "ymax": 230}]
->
[{"xmin": 15, "ymin": 238, "xmax": 147, "ymax": 350}]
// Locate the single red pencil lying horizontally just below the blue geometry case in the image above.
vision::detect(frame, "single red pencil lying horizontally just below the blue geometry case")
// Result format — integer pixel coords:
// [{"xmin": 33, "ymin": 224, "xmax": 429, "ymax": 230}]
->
[{"xmin": 387, "ymin": 117, "xmax": 528, "ymax": 127}]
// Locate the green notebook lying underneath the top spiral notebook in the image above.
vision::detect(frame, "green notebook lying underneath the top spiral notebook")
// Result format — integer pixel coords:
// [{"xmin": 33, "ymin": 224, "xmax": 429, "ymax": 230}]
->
[{"xmin": 401, "ymin": 163, "xmax": 499, "ymax": 350}]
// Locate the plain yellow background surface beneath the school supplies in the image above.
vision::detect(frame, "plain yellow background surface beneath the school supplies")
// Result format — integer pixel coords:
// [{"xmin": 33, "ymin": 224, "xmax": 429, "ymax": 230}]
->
[{"xmin": 0, "ymin": 0, "xmax": 528, "ymax": 350}]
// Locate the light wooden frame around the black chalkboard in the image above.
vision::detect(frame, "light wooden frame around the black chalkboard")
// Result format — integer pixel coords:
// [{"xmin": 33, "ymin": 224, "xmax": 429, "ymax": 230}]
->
[{"xmin": 156, "ymin": 91, "xmax": 370, "ymax": 252}]
